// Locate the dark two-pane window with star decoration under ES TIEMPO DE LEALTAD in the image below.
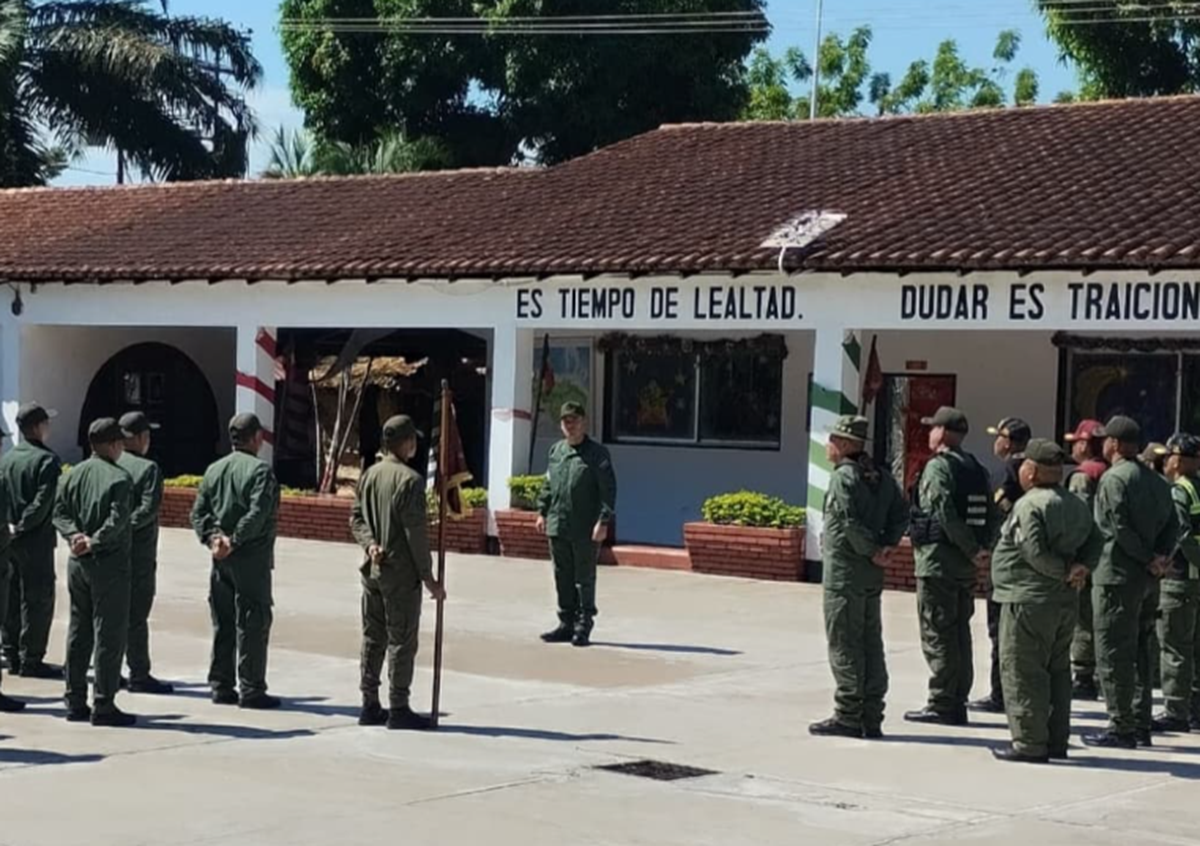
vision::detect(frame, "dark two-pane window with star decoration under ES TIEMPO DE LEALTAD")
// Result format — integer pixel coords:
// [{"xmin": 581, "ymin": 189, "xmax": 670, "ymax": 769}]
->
[{"xmin": 606, "ymin": 341, "xmax": 784, "ymax": 449}]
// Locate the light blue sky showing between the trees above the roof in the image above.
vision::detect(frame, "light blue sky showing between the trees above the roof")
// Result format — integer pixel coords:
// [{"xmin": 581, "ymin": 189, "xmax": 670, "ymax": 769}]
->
[{"xmin": 59, "ymin": 0, "xmax": 1074, "ymax": 185}]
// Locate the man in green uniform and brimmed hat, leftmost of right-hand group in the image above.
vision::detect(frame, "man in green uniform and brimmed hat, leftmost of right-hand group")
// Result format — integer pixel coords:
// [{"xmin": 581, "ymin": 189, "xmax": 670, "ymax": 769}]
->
[{"xmin": 809, "ymin": 416, "xmax": 908, "ymax": 738}]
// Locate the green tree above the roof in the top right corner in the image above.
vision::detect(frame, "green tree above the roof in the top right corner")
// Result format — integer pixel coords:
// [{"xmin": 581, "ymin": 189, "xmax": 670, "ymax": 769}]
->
[{"xmin": 1038, "ymin": 0, "xmax": 1200, "ymax": 100}]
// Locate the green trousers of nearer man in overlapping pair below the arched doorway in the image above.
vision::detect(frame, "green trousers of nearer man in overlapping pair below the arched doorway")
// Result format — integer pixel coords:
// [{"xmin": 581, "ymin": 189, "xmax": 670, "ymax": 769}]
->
[{"xmin": 65, "ymin": 553, "xmax": 130, "ymax": 713}]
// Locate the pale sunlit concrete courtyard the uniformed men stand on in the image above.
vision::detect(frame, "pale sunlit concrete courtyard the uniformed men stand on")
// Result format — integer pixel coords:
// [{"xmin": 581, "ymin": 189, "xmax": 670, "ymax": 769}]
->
[{"xmin": 0, "ymin": 532, "xmax": 1200, "ymax": 846}]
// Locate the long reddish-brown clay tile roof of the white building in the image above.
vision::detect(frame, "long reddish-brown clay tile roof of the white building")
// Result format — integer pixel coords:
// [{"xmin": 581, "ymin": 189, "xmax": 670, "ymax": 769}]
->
[{"xmin": 0, "ymin": 97, "xmax": 1200, "ymax": 281}]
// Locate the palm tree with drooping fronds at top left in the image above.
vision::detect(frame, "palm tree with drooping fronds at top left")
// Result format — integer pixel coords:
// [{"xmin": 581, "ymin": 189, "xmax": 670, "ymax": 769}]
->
[{"xmin": 0, "ymin": 0, "xmax": 263, "ymax": 186}]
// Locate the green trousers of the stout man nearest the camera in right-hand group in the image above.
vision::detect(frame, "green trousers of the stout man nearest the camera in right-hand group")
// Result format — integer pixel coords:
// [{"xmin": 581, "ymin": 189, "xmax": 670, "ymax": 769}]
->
[{"xmin": 1000, "ymin": 598, "xmax": 1079, "ymax": 755}]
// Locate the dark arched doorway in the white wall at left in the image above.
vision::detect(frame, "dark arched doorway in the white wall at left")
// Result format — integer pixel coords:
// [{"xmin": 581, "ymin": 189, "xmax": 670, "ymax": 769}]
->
[{"xmin": 79, "ymin": 342, "xmax": 221, "ymax": 478}]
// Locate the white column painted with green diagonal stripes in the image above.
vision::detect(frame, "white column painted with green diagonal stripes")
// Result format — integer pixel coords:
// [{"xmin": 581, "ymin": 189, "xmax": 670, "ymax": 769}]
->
[{"xmin": 804, "ymin": 326, "xmax": 863, "ymax": 560}]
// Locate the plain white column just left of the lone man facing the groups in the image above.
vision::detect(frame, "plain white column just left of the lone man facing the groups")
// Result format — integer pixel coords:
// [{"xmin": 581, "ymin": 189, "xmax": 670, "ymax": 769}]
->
[{"xmin": 487, "ymin": 324, "xmax": 534, "ymax": 534}]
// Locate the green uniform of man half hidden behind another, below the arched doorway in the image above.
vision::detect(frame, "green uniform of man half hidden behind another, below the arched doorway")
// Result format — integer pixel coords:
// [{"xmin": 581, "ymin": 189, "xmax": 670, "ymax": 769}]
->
[{"xmin": 116, "ymin": 450, "xmax": 162, "ymax": 684}]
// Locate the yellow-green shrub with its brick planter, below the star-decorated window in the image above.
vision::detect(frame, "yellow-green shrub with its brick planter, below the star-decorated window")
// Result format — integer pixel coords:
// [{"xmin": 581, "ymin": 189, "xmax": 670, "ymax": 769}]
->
[{"xmin": 683, "ymin": 491, "xmax": 804, "ymax": 582}]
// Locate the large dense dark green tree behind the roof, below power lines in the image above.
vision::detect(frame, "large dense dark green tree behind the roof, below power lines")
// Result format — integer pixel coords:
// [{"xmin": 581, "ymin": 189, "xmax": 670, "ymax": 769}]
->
[{"xmin": 282, "ymin": 0, "xmax": 763, "ymax": 166}]
